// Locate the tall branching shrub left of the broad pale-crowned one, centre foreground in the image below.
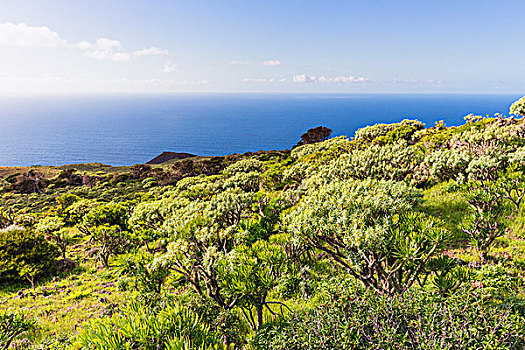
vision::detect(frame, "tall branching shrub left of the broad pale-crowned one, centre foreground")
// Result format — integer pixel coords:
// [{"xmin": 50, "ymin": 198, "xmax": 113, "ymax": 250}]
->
[{"xmin": 166, "ymin": 190, "xmax": 285, "ymax": 344}]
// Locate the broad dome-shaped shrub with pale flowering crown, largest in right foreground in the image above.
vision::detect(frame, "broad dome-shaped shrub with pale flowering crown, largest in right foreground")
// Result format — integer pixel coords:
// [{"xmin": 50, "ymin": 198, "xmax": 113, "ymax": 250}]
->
[{"xmin": 285, "ymin": 180, "xmax": 448, "ymax": 295}]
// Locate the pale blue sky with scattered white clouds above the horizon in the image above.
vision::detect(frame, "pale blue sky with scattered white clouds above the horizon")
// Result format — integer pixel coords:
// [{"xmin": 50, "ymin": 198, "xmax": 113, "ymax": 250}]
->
[{"xmin": 0, "ymin": 0, "xmax": 525, "ymax": 96}]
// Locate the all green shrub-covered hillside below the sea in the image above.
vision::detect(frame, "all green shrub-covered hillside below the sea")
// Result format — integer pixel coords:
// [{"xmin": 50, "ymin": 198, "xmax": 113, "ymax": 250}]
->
[{"xmin": 0, "ymin": 99, "xmax": 525, "ymax": 350}]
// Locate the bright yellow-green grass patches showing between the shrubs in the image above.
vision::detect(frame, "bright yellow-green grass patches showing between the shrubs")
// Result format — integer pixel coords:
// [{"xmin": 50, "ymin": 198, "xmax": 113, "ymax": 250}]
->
[{"xmin": 4, "ymin": 184, "xmax": 525, "ymax": 342}]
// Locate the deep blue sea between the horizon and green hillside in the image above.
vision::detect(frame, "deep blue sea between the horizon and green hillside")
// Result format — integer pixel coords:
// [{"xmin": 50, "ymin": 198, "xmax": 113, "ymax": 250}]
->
[{"xmin": 0, "ymin": 94, "xmax": 521, "ymax": 166}]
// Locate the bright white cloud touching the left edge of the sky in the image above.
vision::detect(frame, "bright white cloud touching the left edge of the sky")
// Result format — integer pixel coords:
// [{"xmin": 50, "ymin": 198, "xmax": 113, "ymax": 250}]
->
[{"xmin": 0, "ymin": 22, "xmax": 67, "ymax": 48}]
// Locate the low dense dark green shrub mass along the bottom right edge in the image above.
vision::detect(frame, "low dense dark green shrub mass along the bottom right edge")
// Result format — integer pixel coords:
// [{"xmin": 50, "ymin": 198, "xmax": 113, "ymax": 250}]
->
[{"xmin": 251, "ymin": 290, "xmax": 525, "ymax": 350}]
